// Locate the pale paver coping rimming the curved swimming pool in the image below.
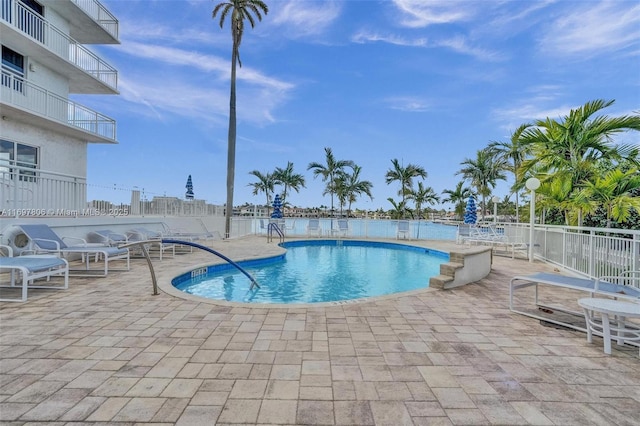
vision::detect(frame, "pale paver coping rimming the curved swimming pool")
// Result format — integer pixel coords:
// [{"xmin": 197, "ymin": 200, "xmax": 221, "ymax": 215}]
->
[{"xmin": 158, "ymin": 236, "xmax": 491, "ymax": 309}]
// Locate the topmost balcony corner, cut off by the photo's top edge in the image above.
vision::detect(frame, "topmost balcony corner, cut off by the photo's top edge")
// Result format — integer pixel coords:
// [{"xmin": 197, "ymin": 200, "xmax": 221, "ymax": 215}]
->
[{"xmin": 40, "ymin": 0, "xmax": 119, "ymax": 44}]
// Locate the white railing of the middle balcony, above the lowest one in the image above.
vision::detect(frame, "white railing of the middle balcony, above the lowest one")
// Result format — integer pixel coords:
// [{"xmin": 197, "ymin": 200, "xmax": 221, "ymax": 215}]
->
[{"xmin": 2, "ymin": 0, "xmax": 118, "ymax": 90}]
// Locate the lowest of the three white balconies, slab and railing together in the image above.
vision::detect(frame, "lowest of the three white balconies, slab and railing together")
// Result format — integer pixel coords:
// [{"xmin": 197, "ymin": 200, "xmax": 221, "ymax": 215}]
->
[{"xmin": 0, "ymin": 70, "xmax": 117, "ymax": 143}]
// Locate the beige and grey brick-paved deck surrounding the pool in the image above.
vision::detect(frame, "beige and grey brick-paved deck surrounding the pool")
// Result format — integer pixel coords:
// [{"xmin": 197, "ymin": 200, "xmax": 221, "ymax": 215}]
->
[{"xmin": 0, "ymin": 237, "xmax": 640, "ymax": 426}]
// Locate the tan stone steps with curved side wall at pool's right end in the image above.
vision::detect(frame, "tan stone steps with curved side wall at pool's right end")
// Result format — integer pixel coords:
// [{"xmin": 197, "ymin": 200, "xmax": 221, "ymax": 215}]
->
[{"xmin": 429, "ymin": 247, "xmax": 493, "ymax": 290}]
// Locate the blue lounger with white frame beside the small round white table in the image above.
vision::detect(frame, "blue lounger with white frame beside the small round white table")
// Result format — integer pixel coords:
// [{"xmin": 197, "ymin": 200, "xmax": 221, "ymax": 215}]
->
[{"xmin": 509, "ymin": 271, "xmax": 640, "ymax": 332}]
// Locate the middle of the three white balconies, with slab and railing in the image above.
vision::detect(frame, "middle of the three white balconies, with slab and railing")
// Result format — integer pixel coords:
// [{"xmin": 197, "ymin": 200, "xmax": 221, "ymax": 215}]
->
[{"xmin": 0, "ymin": 0, "xmax": 118, "ymax": 94}]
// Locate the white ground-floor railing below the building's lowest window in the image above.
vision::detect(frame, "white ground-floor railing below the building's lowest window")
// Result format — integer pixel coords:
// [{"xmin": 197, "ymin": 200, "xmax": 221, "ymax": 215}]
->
[{"xmin": 0, "ymin": 161, "xmax": 87, "ymax": 213}]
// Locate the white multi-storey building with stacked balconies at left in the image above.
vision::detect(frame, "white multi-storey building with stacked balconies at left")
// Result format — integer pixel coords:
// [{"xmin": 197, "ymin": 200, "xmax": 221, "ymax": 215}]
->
[{"xmin": 0, "ymin": 0, "xmax": 119, "ymax": 212}]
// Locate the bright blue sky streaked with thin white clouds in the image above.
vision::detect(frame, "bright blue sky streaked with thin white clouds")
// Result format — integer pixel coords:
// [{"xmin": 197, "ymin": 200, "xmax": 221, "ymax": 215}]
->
[{"xmin": 81, "ymin": 0, "xmax": 640, "ymax": 209}]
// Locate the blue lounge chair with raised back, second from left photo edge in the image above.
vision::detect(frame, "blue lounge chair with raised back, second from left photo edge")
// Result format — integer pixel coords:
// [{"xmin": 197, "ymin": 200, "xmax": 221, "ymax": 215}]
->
[{"xmin": 16, "ymin": 224, "xmax": 130, "ymax": 277}]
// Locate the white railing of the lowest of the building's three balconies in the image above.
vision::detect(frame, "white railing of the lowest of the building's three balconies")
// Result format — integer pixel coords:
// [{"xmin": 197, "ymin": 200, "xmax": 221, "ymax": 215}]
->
[{"xmin": 0, "ymin": 70, "xmax": 116, "ymax": 142}]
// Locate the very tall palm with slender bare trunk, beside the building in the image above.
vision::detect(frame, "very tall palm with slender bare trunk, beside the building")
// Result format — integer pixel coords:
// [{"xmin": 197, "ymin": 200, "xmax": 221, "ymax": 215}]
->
[{"xmin": 212, "ymin": 0, "xmax": 269, "ymax": 238}]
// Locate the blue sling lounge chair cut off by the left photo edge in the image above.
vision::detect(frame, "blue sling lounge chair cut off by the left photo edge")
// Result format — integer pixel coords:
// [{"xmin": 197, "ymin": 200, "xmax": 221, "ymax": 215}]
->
[{"xmin": 0, "ymin": 245, "xmax": 69, "ymax": 302}]
